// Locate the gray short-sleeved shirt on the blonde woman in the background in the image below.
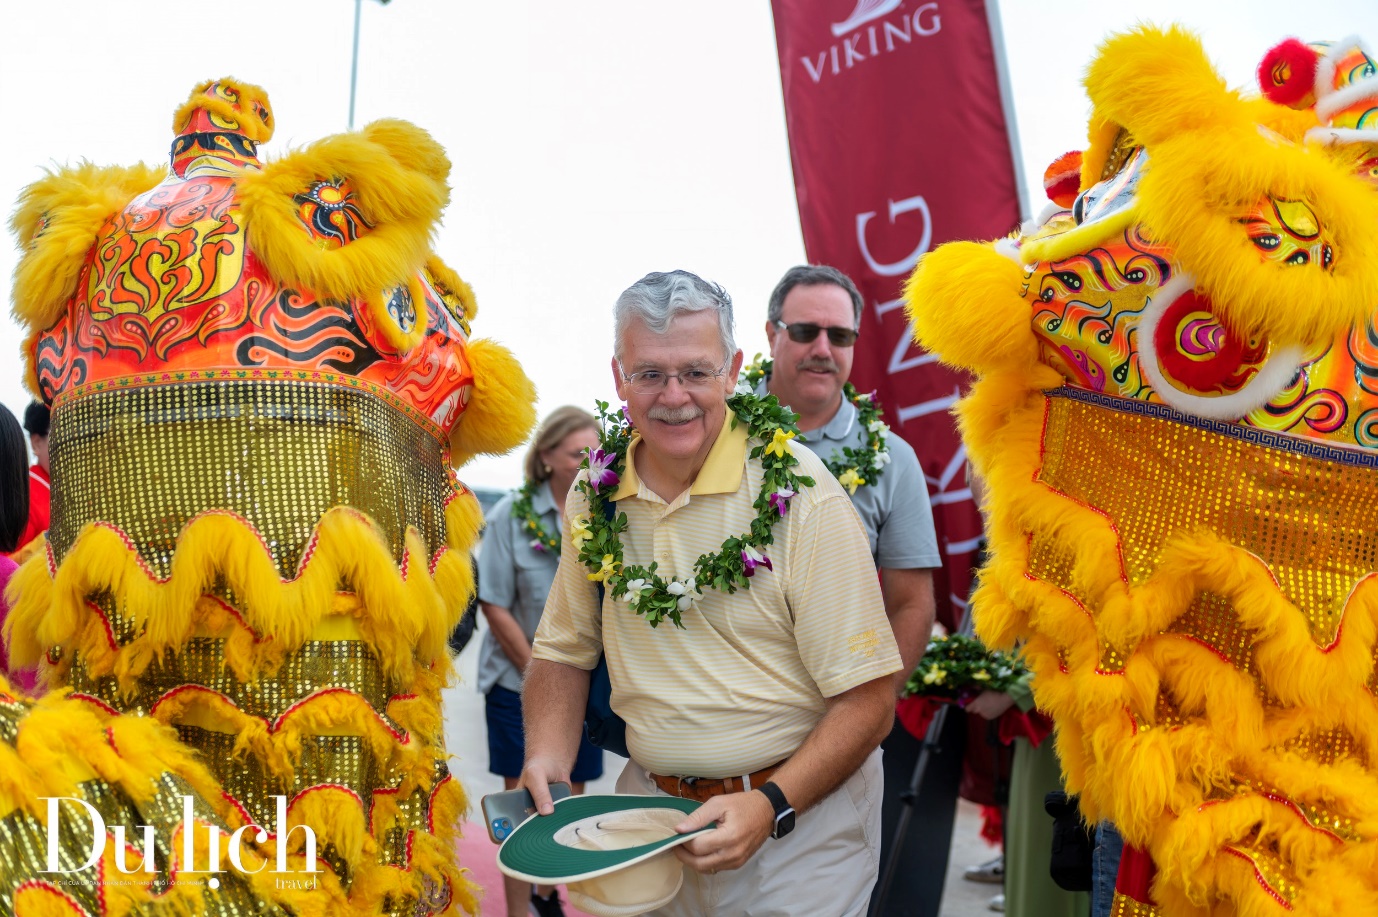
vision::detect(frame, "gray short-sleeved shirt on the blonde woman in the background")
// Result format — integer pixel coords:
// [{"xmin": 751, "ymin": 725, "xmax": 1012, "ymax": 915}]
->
[{"xmin": 478, "ymin": 481, "xmax": 561, "ymax": 694}]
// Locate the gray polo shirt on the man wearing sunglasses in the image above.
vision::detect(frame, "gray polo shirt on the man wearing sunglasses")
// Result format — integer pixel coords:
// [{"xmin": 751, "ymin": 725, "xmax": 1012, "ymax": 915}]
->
[{"xmin": 757, "ymin": 379, "xmax": 943, "ymax": 570}]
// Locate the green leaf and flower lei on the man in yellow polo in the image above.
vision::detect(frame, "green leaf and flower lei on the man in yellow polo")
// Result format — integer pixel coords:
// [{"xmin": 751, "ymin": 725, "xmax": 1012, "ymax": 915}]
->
[{"xmin": 569, "ymin": 393, "xmax": 813, "ymax": 629}]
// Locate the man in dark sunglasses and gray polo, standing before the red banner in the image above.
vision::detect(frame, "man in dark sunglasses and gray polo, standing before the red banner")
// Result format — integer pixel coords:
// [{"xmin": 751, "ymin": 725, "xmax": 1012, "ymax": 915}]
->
[{"xmin": 755, "ymin": 265, "xmax": 943, "ymax": 678}]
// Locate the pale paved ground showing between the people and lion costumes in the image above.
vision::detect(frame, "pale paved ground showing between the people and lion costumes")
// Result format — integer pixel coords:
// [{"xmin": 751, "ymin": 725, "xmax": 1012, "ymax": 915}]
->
[{"xmin": 444, "ymin": 619, "xmax": 999, "ymax": 917}]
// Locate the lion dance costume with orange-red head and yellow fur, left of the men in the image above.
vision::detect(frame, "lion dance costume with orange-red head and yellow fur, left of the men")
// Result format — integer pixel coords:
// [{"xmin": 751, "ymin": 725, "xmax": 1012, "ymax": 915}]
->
[{"xmin": 0, "ymin": 80, "xmax": 533, "ymax": 917}]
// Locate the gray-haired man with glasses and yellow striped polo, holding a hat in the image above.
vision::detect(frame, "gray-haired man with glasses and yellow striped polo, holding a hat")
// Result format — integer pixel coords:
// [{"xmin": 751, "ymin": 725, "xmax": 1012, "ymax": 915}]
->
[{"xmin": 522, "ymin": 272, "xmax": 901, "ymax": 916}]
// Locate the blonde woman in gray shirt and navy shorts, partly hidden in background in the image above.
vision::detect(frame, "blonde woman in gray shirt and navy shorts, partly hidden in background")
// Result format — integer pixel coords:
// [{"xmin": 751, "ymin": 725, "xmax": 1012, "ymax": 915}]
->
[{"xmin": 478, "ymin": 405, "xmax": 602, "ymax": 917}]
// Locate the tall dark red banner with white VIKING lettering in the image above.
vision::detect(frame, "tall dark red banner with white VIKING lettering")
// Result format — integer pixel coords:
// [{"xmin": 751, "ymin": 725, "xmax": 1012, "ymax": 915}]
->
[{"xmin": 773, "ymin": 0, "xmax": 1020, "ymax": 626}]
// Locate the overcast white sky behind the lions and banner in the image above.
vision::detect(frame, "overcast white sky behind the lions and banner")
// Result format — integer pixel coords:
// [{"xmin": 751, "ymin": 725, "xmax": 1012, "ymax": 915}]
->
[{"xmin": 0, "ymin": 0, "xmax": 1378, "ymax": 485}]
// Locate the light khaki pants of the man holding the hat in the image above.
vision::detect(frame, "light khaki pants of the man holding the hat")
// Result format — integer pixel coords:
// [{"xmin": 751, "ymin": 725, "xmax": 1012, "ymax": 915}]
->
[{"xmin": 617, "ymin": 749, "xmax": 885, "ymax": 917}]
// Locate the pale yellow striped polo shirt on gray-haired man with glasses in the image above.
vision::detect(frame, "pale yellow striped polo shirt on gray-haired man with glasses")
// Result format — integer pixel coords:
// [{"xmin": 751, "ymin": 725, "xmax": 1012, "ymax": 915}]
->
[{"xmin": 532, "ymin": 411, "xmax": 901, "ymax": 778}]
